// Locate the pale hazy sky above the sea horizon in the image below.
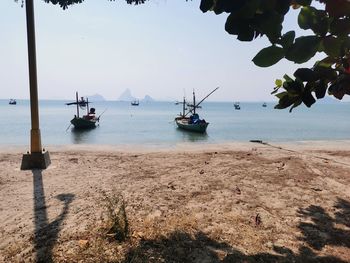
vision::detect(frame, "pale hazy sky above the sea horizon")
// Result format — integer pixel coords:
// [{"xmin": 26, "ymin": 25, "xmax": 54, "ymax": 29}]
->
[{"xmin": 0, "ymin": 0, "xmax": 318, "ymax": 101}]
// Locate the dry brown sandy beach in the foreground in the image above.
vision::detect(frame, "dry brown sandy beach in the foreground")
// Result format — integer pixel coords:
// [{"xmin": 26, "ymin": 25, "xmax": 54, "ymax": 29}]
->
[{"xmin": 0, "ymin": 142, "xmax": 350, "ymax": 263}]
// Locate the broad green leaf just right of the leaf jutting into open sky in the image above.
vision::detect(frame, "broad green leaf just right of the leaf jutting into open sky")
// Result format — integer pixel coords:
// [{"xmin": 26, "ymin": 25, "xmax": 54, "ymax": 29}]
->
[{"xmin": 286, "ymin": 36, "xmax": 320, "ymax": 64}]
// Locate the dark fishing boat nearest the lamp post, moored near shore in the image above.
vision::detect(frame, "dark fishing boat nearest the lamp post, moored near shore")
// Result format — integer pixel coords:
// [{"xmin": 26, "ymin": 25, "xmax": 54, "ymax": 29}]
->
[{"xmin": 66, "ymin": 92, "xmax": 101, "ymax": 129}]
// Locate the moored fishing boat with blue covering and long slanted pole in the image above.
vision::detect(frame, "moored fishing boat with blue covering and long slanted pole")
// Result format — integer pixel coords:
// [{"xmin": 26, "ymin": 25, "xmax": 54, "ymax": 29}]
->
[{"xmin": 175, "ymin": 87, "xmax": 218, "ymax": 133}]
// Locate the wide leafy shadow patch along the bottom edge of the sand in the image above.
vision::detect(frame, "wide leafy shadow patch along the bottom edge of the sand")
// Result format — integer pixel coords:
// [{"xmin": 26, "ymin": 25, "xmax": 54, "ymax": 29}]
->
[{"xmin": 124, "ymin": 232, "xmax": 346, "ymax": 263}]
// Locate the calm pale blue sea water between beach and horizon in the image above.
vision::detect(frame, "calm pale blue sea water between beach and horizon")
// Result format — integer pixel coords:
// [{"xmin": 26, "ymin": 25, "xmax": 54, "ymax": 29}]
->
[{"xmin": 0, "ymin": 100, "xmax": 350, "ymax": 146}]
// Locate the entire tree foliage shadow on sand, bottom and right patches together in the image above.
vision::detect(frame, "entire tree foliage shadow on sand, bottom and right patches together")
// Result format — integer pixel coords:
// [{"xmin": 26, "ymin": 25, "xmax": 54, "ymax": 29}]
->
[{"xmin": 124, "ymin": 199, "xmax": 350, "ymax": 263}]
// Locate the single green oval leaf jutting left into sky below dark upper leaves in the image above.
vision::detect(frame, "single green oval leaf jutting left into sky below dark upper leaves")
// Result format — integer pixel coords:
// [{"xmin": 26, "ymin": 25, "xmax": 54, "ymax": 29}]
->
[{"xmin": 253, "ymin": 46, "xmax": 284, "ymax": 67}]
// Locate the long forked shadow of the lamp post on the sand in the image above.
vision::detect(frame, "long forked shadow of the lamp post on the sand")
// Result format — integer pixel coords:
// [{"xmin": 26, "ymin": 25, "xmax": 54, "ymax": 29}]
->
[{"xmin": 32, "ymin": 170, "xmax": 74, "ymax": 262}]
